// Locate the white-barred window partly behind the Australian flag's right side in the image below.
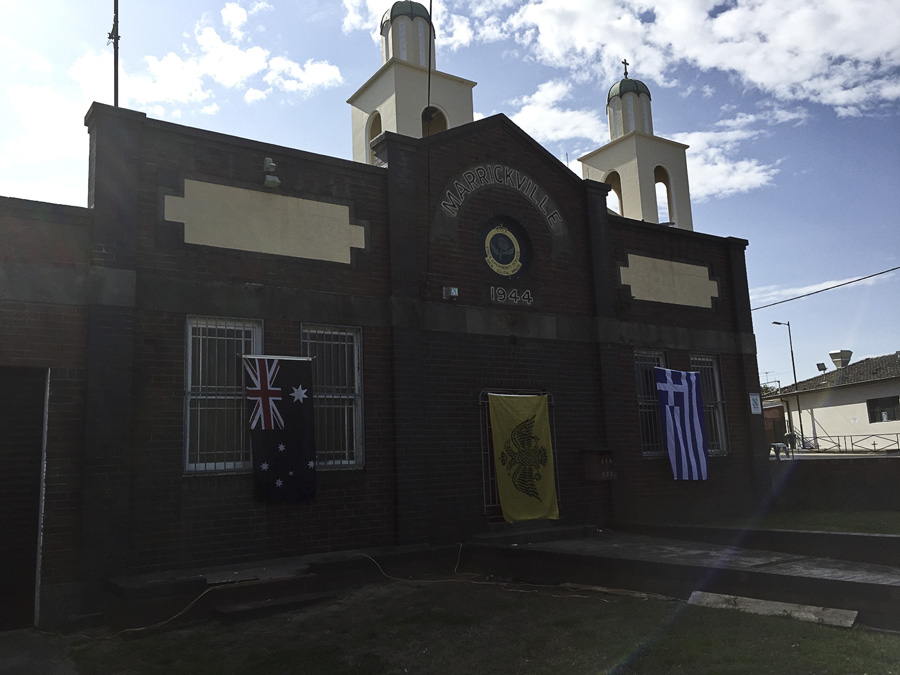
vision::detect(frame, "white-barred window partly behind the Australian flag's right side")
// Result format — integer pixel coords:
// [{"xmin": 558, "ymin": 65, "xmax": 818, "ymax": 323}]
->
[{"xmin": 300, "ymin": 324, "xmax": 365, "ymax": 469}]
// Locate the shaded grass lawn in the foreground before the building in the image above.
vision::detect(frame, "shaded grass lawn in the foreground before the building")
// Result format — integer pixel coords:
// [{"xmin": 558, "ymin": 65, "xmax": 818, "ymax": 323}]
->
[{"xmin": 70, "ymin": 581, "xmax": 900, "ymax": 675}]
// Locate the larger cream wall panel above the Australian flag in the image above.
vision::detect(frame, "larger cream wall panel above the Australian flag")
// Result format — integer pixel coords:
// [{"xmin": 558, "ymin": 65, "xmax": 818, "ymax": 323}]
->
[{"xmin": 165, "ymin": 180, "xmax": 366, "ymax": 263}]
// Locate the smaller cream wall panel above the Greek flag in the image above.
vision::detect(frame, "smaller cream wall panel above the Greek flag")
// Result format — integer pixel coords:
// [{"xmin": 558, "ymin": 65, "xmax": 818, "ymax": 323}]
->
[{"xmin": 620, "ymin": 254, "xmax": 719, "ymax": 307}]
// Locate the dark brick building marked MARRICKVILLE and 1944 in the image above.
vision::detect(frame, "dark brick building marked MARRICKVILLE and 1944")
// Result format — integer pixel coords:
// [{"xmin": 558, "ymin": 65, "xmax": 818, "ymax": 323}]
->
[{"xmin": 0, "ymin": 3, "xmax": 768, "ymax": 625}]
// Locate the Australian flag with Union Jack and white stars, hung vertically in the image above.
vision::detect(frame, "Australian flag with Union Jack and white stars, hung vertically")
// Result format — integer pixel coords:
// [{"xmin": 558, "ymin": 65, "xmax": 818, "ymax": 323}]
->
[{"xmin": 244, "ymin": 356, "xmax": 316, "ymax": 502}]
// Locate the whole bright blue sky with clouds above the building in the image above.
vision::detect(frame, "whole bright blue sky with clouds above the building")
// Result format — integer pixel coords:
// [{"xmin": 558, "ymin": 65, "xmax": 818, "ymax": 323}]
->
[{"xmin": 0, "ymin": 0, "xmax": 900, "ymax": 384}]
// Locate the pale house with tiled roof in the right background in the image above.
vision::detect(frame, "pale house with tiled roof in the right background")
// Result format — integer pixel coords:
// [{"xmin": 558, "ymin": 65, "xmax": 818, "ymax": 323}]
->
[{"xmin": 764, "ymin": 350, "xmax": 900, "ymax": 452}]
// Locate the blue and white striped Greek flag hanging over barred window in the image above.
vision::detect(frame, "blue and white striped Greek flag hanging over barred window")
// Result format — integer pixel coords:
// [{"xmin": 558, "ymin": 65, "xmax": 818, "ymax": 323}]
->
[{"xmin": 654, "ymin": 368, "xmax": 709, "ymax": 480}]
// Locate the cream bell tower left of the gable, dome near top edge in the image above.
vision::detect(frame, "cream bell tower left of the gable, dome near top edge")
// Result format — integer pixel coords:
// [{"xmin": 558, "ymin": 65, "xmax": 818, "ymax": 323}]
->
[{"xmin": 347, "ymin": 1, "xmax": 475, "ymax": 164}]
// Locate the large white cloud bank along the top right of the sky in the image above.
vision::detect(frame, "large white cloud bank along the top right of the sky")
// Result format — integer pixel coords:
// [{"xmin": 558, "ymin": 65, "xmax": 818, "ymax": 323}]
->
[{"xmin": 428, "ymin": 0, "xmax": 900, "ymax": 116}]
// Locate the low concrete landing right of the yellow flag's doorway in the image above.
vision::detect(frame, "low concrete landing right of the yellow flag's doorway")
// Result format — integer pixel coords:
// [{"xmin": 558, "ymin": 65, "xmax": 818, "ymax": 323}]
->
[{"xmin": 463, "ymin": 532, "xmax": 900, "ymax": 630}]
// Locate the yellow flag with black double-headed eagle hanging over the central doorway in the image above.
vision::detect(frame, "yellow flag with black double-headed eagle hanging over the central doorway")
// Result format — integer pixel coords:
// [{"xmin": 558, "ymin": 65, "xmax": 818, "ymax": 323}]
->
[{"xmin": 488, "ymin": 394, "xmax": 559, "ymax": 523}]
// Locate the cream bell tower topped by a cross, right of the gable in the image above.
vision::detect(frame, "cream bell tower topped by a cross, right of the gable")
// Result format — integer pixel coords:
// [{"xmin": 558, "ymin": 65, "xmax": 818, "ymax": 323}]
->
[{"xmin": 578, "ymin": 61, "xmax": 694, "ymax": 230}]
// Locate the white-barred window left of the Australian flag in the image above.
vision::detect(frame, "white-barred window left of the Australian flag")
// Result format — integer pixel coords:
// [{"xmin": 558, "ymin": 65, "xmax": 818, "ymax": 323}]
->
[{"xmin": 184, "ymin": 316, "xmax": 263, "ymax": 472}]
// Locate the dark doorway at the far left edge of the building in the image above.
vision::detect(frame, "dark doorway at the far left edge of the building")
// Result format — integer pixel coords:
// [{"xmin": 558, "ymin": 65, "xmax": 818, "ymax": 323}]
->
[{"xmin": 0, "ymin": 368, "xmax": 47, "ymax": 630}]
